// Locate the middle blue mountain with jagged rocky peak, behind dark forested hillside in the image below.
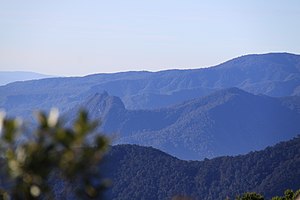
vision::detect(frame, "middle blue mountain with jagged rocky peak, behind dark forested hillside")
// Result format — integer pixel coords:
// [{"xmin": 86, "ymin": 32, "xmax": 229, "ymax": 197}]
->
[{"xmin": 66, "ymin": 88, "xmax": 300, "ymax": 160}]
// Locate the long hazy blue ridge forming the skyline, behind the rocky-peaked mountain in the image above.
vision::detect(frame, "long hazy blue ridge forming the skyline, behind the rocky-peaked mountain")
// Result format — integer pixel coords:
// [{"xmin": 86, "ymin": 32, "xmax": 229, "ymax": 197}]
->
[{"xmin": 0, "ymin": 53, "xmax": 300, "ymax": 117}]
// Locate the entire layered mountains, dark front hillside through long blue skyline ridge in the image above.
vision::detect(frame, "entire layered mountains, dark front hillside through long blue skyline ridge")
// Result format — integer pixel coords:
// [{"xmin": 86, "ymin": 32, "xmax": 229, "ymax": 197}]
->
[{"xmin": 0, "ymin": 53, "xmax": 300, "ymax": 200}]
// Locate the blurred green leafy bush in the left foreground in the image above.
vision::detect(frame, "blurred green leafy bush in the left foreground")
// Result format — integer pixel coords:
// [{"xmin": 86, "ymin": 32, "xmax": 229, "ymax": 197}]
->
[{"xmin": 0, "ymin": 110, "xmax": 109, "ymax": 199}]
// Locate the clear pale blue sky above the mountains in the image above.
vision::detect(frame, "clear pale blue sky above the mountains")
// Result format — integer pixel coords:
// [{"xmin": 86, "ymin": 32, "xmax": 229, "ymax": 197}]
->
[{"xmin": 0, "ymin": 0, "xmax": 300, "ymax": 76}]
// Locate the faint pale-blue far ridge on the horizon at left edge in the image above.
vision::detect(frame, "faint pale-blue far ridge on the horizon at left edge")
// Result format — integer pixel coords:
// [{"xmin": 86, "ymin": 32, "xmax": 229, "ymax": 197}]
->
[{"xmin": 0, "ymin": 71, "xmax": 53, "ymax": 86}]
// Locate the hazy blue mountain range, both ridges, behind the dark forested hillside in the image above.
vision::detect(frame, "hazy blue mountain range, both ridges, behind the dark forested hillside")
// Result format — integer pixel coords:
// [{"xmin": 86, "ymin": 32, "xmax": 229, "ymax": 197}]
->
[{"xmin": 0, "ymin": 53, "xmax": 300, "ymax": 160}]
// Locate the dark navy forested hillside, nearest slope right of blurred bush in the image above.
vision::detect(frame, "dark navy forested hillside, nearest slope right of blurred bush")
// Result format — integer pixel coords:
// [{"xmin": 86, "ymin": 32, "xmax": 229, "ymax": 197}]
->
[{"xmin": 105, "ymin": 136, "xmax": 300, "ymax": 200}]
